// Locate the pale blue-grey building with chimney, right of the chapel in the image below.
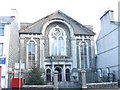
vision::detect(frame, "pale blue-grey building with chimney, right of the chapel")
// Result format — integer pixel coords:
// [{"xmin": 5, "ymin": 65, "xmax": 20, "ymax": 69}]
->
[{"xmin": 96, "ymin": 10, "xmax": 120, "ymax": 81}]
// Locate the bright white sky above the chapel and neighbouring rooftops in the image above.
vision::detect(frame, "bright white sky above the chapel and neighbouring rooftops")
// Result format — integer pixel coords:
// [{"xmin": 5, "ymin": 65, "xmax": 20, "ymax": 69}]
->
[{"xmin": 0, "ymin": 0, "xmax": 119, "ymax": 39}]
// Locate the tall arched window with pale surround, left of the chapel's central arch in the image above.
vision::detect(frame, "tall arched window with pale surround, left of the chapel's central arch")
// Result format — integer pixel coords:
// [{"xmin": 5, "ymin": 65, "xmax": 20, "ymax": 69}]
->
[{"xmin": 26, "ymin": 40, "xmax": 36, "ymax": 69}]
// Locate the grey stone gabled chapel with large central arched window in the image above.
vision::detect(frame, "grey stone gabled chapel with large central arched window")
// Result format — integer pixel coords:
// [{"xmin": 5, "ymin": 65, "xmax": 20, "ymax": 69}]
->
[{"xmin": 19, "ymin": 10, "xmax": 95, "ymax": 85}]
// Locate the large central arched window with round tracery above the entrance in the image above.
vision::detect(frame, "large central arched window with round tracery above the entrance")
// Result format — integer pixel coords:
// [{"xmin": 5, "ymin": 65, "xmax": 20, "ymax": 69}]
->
[{"xmin": 49, "ymin": 25, "xmax": 66, "ymax": 56}]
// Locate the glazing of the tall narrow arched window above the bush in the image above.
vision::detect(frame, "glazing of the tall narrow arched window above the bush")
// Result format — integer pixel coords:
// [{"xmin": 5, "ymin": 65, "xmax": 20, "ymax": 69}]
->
[{"xmin": 28, "ymin": 41, "xmax": 35, "ymax": 68}]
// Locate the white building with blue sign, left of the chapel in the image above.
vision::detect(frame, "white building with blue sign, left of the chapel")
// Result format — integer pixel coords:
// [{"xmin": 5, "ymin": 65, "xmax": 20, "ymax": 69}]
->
[{"xmin": 0, "ymin": 9, "xmax": 19, "ymax": 88}]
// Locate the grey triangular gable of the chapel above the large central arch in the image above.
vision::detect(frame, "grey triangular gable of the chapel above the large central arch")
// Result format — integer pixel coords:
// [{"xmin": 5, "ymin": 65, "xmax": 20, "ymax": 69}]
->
[{"xmin": 19, "ymin": 10, "xmax": 95, "ymax": 35}]
